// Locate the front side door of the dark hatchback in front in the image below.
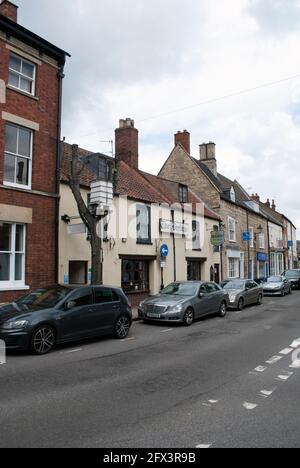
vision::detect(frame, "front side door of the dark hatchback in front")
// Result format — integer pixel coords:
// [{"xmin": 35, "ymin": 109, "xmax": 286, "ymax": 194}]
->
[{"xmin": 57, "ymin": 287, "xmax": 93, "ymax": 341}]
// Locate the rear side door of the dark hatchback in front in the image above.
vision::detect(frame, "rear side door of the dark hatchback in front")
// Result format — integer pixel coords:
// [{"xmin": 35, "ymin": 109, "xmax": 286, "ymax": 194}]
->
[{"xmin": 93, "ymin": 287, "xmax": 121, "ymax": 335}]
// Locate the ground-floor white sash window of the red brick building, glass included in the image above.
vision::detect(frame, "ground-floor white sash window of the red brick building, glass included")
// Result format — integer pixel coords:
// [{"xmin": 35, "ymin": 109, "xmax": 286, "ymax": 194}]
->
[{"xmin": 0, "ymin": 221, "xmax": 26, "ymax": 289}]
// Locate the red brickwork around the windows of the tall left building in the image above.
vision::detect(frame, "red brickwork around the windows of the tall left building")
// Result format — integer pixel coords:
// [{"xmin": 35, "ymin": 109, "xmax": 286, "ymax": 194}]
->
[{"xmin": 0, "ymin": 36, "xmax": 59, "ymax": 303}]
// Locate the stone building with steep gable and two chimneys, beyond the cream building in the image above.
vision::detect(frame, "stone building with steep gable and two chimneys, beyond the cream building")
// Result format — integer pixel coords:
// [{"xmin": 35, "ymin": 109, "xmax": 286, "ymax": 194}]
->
[{"xmin": 159, "ymin": 130, "xmax": 269, "ymax": 279}]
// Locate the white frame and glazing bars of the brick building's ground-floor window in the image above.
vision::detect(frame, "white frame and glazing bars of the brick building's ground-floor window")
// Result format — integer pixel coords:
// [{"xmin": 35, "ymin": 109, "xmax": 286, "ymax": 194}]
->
[{"xmin": 0, "ymin": 221, "xmax": 27, "ymax": 290}]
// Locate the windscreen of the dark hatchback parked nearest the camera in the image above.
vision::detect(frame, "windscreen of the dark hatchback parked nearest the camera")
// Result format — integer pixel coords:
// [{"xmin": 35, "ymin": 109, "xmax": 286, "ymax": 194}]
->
[{"xmin": 16, "ymin": 287, "xmax": 71, "ymax": 309}]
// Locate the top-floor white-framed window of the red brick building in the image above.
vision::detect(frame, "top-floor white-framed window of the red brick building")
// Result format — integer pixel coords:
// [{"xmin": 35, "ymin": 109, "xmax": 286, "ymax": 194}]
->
[{"xmin": 8, "ymin": 54, "xmax": 36, "ymax": 96}]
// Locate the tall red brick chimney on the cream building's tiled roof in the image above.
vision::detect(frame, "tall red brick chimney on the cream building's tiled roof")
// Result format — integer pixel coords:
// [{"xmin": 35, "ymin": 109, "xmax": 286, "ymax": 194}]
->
[{"xmin": 115, "ymin": 118, "xmax": 139, "ymax": 169}]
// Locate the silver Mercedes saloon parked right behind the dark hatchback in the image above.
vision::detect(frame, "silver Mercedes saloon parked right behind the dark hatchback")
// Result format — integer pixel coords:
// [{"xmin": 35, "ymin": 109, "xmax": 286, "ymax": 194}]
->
[{"xmin": 138, "ymin": 281, "xmax": 229, "ymax": 326}]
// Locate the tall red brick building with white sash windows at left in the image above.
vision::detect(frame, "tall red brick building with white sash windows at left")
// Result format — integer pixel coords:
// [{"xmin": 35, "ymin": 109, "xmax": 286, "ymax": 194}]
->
[{"xmin": 0, "ymin": 0, "xmax": 68, "ymax": 302}]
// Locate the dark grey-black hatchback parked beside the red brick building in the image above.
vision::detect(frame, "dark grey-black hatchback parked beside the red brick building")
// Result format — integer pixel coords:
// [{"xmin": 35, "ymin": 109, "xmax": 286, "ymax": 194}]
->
[{"xmin": 0, "ymin": 286, "xmax": 132, "ymax": 355}]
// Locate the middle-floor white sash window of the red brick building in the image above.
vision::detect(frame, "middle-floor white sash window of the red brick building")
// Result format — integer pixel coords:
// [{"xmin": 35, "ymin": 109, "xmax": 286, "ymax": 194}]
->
[{"xmin": 3, "ymin": 123, "xmax": 33, "ymax": 189}]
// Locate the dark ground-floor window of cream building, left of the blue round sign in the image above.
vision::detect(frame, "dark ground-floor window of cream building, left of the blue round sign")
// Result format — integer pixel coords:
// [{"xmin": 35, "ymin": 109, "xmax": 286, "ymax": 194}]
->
[{"xmin": 122, "ymin": 259, "xmax": 149, "ymax": 293}]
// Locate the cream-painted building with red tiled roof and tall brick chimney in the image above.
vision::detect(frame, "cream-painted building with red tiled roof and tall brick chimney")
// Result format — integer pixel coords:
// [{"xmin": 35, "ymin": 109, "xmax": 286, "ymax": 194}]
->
[{"xmin": 59, "ymin": 119, "xmax": 221, "ymax": 305}]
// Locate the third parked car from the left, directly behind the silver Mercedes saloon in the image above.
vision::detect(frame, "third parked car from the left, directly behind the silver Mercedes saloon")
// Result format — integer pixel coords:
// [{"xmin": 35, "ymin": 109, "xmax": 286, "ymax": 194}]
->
[{"xmin": 220, "ymin": 280, "xmax": 263, "ymax": 310}]
